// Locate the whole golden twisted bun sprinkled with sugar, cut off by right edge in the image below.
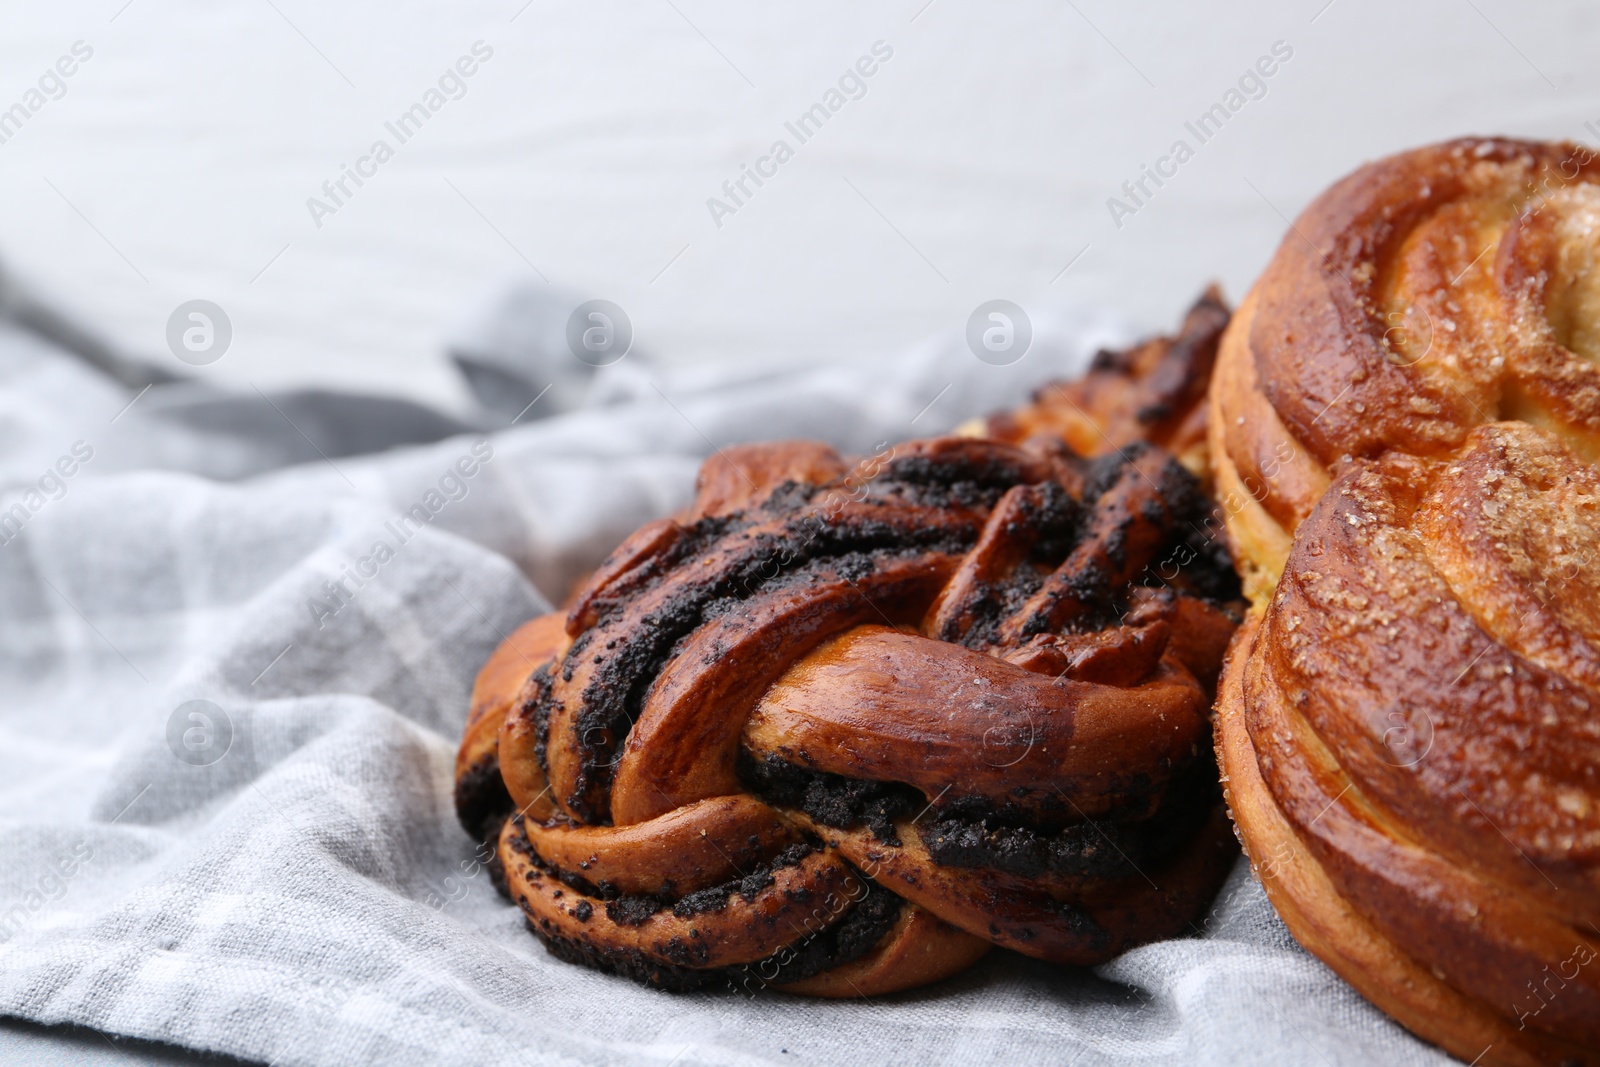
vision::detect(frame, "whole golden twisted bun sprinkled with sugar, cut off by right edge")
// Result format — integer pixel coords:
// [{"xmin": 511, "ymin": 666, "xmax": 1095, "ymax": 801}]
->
[{"xmin": 1210, "ymin": 139, "xmax": 1600, "ymax": 1064}]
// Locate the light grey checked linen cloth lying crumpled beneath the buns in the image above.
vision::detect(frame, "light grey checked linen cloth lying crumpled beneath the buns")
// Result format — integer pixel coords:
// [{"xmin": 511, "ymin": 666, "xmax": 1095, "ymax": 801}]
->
[{"xmin": 0, "ymin": 279, "xmax": 1450, "ymax": 1067}]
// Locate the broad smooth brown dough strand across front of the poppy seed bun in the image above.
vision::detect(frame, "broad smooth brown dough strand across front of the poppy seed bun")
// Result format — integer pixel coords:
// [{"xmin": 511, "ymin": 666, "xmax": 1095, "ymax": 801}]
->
[{"xmin": 742, "ymin": 624, "xmax": 1203, "ymax": 816}]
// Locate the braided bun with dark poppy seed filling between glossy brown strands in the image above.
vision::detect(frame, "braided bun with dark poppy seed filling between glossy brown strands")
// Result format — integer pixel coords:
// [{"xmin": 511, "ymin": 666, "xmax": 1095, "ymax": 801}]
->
[{"xmin": 456, "ymin": 295, "xmax": 1243, "ymax": 997}]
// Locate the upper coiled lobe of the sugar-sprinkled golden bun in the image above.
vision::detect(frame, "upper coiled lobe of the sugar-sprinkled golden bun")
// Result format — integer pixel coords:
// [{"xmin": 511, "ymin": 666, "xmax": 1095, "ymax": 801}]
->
[{"xmin": 1211, "ymin": 138, "xmax": 1600, "ymax": 595}]
